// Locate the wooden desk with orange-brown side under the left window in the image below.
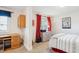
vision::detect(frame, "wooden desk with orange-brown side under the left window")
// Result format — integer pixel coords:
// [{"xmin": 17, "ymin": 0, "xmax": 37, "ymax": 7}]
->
[{"xmin": 0, "ymin": 33, "xmax": 22, "ymax": 52}]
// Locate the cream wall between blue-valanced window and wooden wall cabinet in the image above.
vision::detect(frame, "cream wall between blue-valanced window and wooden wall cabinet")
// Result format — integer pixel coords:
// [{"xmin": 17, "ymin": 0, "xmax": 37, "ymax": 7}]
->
[{"xmin": 0, "ymin": 7, "xmax": 24, "ymax": 35}]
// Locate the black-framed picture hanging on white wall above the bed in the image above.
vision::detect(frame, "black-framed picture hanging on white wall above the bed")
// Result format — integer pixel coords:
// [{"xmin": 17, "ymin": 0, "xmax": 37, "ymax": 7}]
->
[{"xmin": 62, "ymin": 17, "xmax": 71, "ymax": 29}]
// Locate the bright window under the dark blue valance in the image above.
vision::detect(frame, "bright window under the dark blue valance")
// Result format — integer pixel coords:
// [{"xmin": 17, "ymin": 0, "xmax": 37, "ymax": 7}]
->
[{"xmin": 0, "ymin": 16, "xmax": 9, "ymax": 31}]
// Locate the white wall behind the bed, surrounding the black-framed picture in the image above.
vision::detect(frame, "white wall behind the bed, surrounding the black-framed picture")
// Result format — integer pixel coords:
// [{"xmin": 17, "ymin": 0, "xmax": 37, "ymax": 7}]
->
[{"xmin": 53, "ymin": 11, "xmax": 79, "ymax": 35}]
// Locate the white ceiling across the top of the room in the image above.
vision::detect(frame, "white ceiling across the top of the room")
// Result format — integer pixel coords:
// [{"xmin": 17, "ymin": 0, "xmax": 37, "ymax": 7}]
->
[{"xmin": 4, "ymin": 6, "xmax": 79, "ymax": 15}]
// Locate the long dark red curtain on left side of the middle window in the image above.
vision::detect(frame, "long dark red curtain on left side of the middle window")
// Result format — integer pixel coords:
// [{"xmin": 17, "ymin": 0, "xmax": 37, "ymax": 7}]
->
[{"xmin": 36, "ymin": 15, "xmax": 41, "ymax": 42}]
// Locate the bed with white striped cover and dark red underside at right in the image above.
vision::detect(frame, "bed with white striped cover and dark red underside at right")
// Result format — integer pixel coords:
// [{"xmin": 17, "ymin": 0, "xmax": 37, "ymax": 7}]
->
[{"xmin": 49, "ymin": 33, "xmax": 79, "ymax": 53}]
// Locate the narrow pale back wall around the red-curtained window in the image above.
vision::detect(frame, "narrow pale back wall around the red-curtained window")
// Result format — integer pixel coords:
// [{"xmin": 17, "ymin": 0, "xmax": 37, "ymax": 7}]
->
[{"xmin": 32, "ymin": 9, "xmax": 54, "ymax": 42}]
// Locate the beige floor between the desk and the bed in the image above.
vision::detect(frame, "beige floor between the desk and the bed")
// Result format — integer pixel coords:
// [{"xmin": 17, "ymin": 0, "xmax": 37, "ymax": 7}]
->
[{"xmin": 4, "ymin": 41, "xmax": 49, "ymax": 53}]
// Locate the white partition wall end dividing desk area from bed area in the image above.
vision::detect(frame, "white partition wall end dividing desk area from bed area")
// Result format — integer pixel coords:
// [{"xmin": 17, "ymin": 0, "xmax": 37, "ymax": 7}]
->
[{"xmin": 24, "ymin": 7, "xmax": 33, "ymax": 51}]
